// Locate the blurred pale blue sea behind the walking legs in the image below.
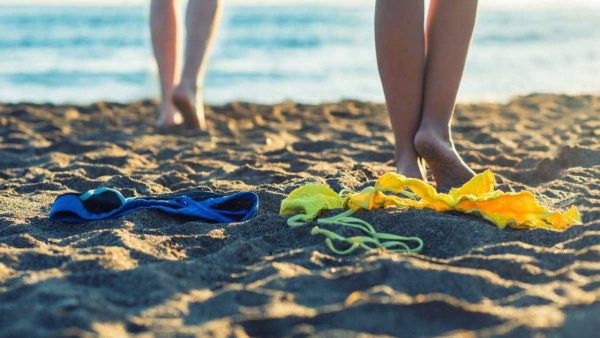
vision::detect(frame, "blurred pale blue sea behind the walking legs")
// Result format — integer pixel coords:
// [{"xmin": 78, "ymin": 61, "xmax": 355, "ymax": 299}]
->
[{"xmin": 0, "ymin": 1, "xmax": 600, "ymax": 103}]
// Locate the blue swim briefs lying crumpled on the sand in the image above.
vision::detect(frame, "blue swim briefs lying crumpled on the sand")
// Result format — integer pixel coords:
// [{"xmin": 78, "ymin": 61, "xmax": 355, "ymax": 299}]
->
[{"xmin": 50, "ymin": 188, "xmax": 259, "ymax": 223}]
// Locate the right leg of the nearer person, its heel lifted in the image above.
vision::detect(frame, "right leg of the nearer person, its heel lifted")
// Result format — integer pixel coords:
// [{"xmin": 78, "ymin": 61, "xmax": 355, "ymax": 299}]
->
[{"xmin": 414, "ymin": 0, "xmax": 477, "ymax": 188}]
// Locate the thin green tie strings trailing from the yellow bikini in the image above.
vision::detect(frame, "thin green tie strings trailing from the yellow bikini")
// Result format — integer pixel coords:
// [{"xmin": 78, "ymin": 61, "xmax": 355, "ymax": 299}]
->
[{"xmin": 288, "ymin": 209, "xmax": 423, "ymax": 255}]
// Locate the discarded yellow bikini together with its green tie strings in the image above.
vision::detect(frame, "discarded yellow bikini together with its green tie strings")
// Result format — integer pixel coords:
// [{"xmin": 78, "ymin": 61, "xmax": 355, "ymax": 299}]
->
[{"xmin": 279, "ymin": 170, "xmax": 581, "ymax": 254}]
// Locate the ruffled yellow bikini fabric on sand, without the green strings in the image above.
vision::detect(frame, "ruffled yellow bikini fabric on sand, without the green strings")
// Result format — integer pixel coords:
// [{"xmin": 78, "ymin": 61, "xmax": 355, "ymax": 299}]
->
[{"xmin": 280, "ymin": 170, "xmax": 581, "ymax": 230}]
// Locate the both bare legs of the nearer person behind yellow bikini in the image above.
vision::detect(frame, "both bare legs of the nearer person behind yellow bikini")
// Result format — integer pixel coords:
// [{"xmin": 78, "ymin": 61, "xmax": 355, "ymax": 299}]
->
[{"xmin": 375, "ymin": 0, "xmax": 477, "ymax": 188}]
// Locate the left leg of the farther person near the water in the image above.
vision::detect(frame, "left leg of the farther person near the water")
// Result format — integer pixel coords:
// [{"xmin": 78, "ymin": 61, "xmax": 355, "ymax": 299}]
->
[{"xmin": 150, "ymin": 0, "xmax": 179, "ymax": 125}]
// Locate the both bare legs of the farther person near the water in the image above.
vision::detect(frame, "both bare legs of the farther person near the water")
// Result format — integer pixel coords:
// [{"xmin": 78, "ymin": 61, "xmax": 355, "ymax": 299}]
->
[{"xmin": 150, "ymin": 0, "xmax": 221, "ymax": 129}]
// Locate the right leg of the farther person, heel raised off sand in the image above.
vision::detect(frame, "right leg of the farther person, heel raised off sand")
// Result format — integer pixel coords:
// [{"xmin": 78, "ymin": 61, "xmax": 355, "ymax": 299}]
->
[{"xmin": 173, "ymin": 0, "xmax": 221, "ymax": 130}]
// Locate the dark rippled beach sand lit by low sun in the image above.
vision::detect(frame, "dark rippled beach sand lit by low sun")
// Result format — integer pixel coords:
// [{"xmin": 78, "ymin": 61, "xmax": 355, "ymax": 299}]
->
[{"xmin": 0, "ymin": 95, "xmax": 600, "ymax": 337}]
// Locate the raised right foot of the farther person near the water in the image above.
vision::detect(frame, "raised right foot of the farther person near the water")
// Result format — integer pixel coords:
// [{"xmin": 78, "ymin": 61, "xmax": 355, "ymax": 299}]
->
[{"xmin": 173, "ymin": 83, "xmax": 206, "ymax": 130}]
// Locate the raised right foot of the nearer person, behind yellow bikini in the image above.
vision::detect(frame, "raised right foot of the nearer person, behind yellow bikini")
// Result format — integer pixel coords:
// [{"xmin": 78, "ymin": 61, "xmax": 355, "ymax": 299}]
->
[{"xmin": 415, "ymin": 125, "xmax": 475, "ymax": 191}]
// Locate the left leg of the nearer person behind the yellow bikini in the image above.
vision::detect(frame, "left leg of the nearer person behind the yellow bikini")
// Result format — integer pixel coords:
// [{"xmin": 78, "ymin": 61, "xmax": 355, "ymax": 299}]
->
[{"xmin": 375, "ymin": 0, "xmax": 425, "ymax": 178}]
